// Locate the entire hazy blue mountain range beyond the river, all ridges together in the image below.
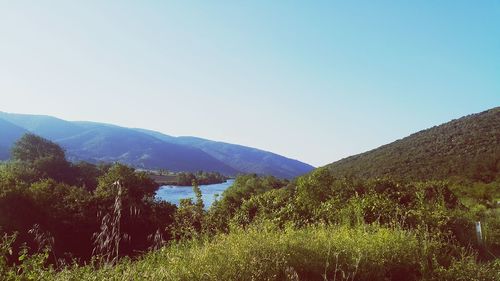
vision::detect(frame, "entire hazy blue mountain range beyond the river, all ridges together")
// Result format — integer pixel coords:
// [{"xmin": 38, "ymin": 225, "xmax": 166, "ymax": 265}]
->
[{"xmin": 0, "ymin": 112, "xmax": 314, "ymax": 178}]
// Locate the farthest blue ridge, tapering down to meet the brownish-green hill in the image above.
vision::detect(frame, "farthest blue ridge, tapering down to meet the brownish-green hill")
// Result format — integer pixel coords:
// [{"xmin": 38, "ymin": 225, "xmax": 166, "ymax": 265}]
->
[{"xmin": 139, "ymin": 129, "xmax": 314, "ymax": 178}]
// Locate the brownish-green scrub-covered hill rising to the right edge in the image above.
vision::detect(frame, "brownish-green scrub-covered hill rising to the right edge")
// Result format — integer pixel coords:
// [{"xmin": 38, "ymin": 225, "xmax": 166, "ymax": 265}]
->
[{"xmin": 327, "ymin": 107, "xmax": 500, "ymax": 182}]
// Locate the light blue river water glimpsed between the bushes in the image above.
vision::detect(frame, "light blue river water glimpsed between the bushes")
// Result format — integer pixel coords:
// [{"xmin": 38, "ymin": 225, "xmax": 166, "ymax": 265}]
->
[{"xmin": 156, "ymin": 179, "xmax": 234, "ymax": 208}]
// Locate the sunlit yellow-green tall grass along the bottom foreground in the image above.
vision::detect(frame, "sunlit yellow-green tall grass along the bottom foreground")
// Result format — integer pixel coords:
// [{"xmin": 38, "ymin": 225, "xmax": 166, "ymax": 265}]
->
[{"xmin": 30, "ymin": 224, "xmax": 500, "ymax": 281}]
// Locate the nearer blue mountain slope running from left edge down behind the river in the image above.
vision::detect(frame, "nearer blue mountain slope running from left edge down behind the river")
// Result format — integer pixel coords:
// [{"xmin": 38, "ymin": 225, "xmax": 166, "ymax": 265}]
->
[{"xmin": 0, "ymin": 113, "xmax": 239, "ymax": 175}]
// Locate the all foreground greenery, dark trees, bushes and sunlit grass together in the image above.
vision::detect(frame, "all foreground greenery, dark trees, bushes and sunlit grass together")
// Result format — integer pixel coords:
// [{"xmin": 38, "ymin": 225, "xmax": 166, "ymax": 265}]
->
[{"xmin": 0, "ymin": 111, "xmax": 500, "ymax": 280}]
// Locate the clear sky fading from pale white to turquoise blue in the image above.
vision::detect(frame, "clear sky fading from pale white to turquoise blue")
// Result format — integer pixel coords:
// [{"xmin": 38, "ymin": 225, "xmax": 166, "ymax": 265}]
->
[{"xmin": 0, "ymin": 0, "xmax": 500, "ymax": 166}]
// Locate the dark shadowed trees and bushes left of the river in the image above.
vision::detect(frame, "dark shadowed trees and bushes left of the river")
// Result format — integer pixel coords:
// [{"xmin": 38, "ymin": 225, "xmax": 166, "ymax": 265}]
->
[{"xmin": 0, "ymin": 134, "xmax": 179, "ymax": 263}]
